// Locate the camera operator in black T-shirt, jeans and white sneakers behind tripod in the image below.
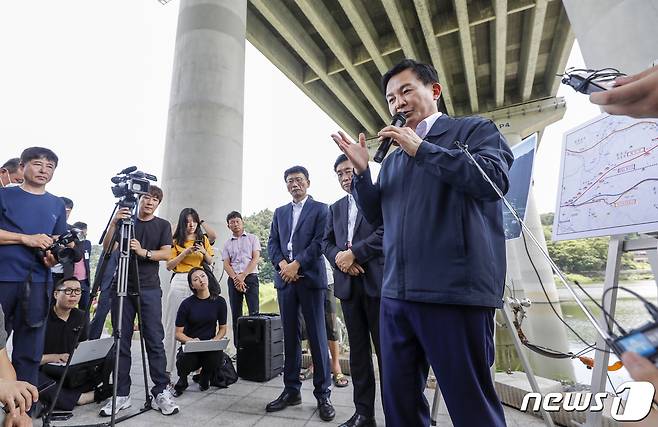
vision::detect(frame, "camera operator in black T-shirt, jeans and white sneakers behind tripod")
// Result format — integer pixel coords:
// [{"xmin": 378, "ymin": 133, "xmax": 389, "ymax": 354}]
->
[{"xmin": 100, "ymin": 185, "xmax": 179, "ymax": 417}]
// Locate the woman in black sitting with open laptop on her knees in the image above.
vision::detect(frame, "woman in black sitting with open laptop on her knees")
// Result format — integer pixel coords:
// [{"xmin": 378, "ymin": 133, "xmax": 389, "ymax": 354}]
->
[{"xmin": 174, "ymin": 267, "xmax": 227, "ymax": 397}]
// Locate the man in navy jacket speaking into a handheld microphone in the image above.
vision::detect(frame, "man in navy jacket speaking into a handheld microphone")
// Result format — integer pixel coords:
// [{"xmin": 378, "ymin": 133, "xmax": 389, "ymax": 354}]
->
[{"xmin": 332, "ymin": 59, "xmax": 513, "ymax": 427}]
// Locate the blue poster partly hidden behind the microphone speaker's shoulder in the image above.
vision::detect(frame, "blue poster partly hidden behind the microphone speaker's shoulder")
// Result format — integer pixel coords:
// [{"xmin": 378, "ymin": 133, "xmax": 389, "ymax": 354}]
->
[{"xmin": 503, "ymin": 133, "xmax": 537, "ymax": 240}]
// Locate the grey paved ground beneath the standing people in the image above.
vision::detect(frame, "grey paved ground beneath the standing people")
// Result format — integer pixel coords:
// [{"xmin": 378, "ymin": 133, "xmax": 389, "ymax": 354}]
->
[{"xmin": 48, "ymin": 341, "xmax": 543, "ymax": 427}]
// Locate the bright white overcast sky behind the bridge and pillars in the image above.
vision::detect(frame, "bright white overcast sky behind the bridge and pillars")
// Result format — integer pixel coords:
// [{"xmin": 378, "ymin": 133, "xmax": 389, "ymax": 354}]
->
[{"xmin": 0, "ymin": 0, "xmax": 598, "ymax": 239}]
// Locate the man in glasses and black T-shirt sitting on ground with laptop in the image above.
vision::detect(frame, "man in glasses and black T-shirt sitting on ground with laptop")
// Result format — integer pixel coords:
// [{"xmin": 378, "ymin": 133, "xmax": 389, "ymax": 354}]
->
[{"xmin": 39, "ymin": 277, "xmax": 109, "ymax": 411}]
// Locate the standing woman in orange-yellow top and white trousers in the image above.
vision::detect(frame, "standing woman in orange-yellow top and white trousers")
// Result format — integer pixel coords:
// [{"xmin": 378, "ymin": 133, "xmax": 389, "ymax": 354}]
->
[{"xmin": 164, "ymin": 208, "xmax": 214, "ymax": 372}]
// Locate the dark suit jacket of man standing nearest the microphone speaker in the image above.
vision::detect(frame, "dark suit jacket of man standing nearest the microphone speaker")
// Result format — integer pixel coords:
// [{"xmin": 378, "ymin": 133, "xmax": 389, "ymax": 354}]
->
[{"xmin": 322, "ymin": 196, "xmax": 384, "ymax": 299}]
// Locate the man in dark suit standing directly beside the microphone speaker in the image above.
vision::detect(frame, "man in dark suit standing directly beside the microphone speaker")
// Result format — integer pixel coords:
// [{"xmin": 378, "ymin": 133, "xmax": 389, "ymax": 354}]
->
[{"xmin": 322, "ymin": 154, "xmax": 384, "ymax": 427}]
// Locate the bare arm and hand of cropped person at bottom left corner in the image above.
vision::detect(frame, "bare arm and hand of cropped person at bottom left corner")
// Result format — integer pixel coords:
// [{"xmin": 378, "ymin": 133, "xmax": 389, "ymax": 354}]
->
[{"xmin": 0, "ymin": 306, "xmax": 39, "ymax": 427}]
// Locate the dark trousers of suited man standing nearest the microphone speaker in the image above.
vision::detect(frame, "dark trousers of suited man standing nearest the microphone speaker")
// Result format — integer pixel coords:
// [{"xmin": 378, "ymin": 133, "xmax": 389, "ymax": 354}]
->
[{"xmin": 341, "ymin": 277, "xmax": 384, "ymax": 417}]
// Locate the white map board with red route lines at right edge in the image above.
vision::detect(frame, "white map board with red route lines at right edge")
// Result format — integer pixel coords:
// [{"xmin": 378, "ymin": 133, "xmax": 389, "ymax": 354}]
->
[{"xmin": 553, "ymin": 114, "xmax": 658, "ymax": 240}]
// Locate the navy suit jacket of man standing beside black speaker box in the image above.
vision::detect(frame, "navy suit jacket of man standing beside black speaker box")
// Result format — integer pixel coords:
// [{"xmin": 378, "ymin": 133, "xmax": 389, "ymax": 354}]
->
[{"xmin": 267, "ymin": 196, "xmax": 327, "ymax": 289}]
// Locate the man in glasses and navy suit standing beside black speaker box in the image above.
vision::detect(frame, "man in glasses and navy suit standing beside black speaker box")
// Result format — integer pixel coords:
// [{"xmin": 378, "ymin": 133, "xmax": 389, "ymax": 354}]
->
[{"xmin": 266, "ymin": 166, "xmax": 336, "ymax": 421}]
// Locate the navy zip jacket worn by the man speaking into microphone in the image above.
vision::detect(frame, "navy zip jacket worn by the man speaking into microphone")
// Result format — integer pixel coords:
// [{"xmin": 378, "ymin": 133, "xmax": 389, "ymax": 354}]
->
[{"xmin": 352, "ymin": 115, "xmax": 514, "ymax": 308}]
